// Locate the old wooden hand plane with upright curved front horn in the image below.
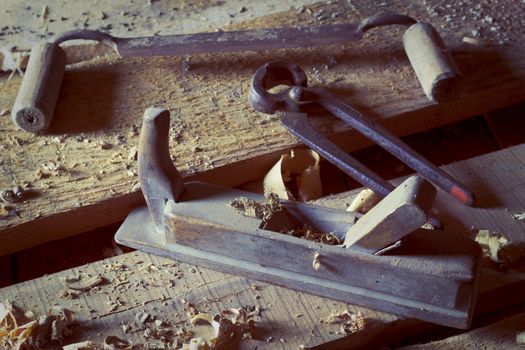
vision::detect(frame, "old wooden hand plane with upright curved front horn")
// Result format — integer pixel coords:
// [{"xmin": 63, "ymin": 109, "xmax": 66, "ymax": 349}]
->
[{"xmin": 115, "ymin": 108, "xmax": 481, "ymax": 328}]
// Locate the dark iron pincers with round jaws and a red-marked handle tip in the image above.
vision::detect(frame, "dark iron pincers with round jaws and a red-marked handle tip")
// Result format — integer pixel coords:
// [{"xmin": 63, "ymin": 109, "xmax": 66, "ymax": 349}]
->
[{"xmin": 249, "ymin": 61, "xmax": 474, "ymax": 205}]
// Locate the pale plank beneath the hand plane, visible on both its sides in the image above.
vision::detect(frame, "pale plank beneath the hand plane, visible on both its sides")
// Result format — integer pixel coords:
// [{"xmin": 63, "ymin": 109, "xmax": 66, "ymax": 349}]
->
[{"xmin": 0, "ymin": 145, "xmax": 525, "ymax": 349}]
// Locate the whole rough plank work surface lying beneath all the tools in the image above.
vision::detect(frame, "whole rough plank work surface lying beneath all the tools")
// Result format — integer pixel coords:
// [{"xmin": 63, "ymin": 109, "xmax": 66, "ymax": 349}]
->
[{"xmin": 0, "ymin": 0, "xmax": 525, "ymax": 349}]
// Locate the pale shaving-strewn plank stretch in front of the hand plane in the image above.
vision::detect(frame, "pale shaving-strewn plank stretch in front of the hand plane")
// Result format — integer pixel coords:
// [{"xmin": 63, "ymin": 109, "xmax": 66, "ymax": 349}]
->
[{"xmin": 0, "ymin": 252, "xmax": 397, "ymax": 349}]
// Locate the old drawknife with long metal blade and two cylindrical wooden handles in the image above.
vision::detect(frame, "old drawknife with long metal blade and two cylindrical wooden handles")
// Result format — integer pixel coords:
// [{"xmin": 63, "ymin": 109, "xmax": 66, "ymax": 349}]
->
[{"xmin": 11, "ymin": 14, "xmax": 461, "ymax": 133}]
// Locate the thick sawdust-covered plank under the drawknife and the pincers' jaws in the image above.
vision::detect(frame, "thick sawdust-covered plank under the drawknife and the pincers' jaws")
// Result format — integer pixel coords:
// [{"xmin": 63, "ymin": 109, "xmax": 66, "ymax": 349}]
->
[{"xmin": 0, "ymin": 1, "xmax": 525, "ymax": 254}]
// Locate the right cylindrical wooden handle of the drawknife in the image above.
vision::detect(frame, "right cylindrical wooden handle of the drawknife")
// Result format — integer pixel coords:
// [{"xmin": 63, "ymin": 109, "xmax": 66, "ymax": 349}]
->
[{"xmin": 403, "ymin": 23, "xmax": 462, "ymax": 102}]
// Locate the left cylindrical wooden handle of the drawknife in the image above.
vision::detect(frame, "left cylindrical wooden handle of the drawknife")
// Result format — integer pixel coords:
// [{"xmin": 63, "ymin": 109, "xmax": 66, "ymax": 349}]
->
[{"xmin": 11, "ymin": 43, "xmax": 66, "ymax": 133}]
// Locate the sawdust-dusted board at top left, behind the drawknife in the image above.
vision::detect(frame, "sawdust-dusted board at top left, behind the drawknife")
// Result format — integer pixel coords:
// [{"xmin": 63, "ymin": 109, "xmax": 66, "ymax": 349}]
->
[{"xmin": 0, "ymin": 0, "xmax": 315, "ymax": 70}]
